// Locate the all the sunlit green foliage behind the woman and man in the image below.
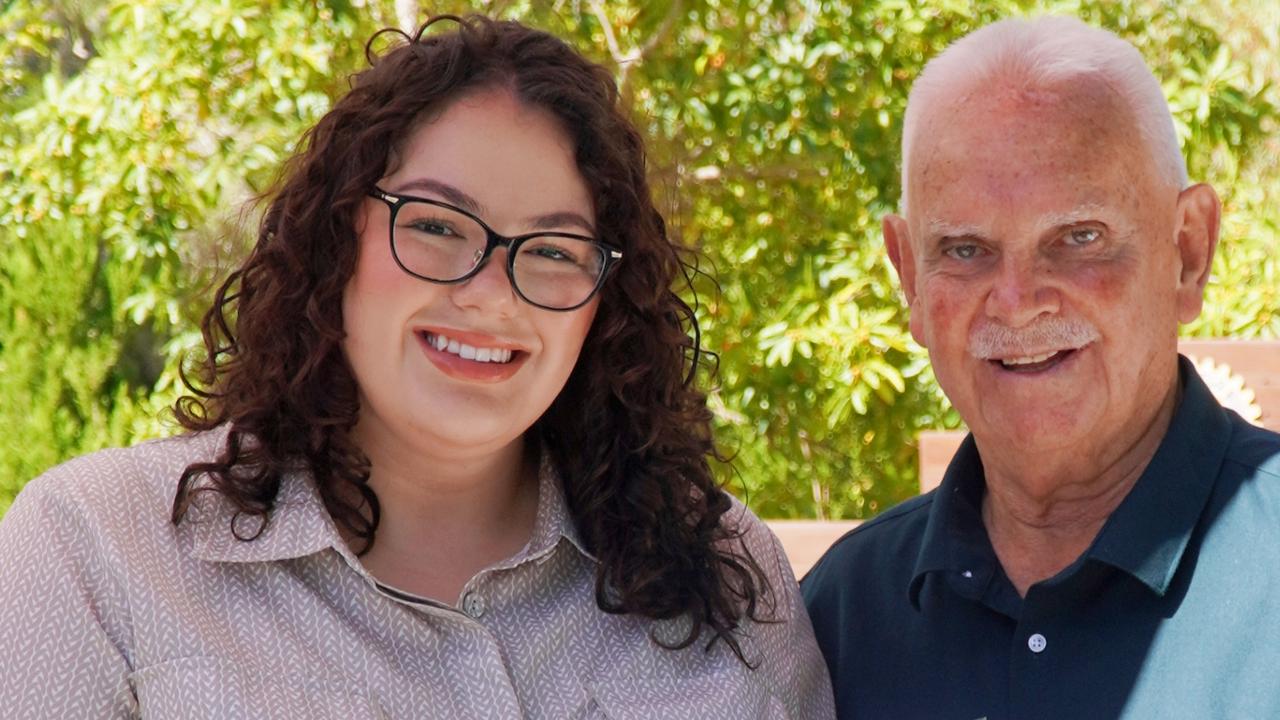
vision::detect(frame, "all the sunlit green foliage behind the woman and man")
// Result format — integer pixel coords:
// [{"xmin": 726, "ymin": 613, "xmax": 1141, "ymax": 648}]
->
[{"xmin": 0, "ymin": 0, "xmax": 1280, "ymax": 518}]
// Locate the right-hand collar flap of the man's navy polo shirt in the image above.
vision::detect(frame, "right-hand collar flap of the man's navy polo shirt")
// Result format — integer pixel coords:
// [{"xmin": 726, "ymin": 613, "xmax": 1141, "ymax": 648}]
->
[{"xmin": 1085, "ymin": 356, "xmax": 1231, "ymax": 596}]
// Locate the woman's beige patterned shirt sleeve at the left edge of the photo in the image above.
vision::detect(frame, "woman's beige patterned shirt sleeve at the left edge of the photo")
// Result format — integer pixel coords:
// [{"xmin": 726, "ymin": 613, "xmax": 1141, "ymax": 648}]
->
[{"xmin": 0, "ymin": 477, "xmax": 137, "ymax": 719}]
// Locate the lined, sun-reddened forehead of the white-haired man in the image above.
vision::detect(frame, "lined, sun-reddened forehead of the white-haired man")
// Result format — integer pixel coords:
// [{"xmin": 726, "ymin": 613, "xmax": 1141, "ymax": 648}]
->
[{"xmin": 906, "ymin": 83, "xmax": 1155, "ymax": 230}]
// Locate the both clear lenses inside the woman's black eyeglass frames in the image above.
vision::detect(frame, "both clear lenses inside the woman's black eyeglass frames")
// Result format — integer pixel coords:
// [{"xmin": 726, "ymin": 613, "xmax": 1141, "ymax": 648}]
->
[{"xmin": 392, "ymin": 201, "xmax": 604, "ymax": 307}]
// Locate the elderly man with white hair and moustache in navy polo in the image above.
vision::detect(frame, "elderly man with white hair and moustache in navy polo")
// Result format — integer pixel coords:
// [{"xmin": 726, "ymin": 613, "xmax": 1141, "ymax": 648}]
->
[{"xmin": 804, "ymin": 18, "xmax": 1280, "ymax": 720}]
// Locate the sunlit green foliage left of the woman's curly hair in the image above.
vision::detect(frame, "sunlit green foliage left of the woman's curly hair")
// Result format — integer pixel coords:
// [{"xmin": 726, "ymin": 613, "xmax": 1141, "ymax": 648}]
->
[{"xmin": 0, "ymin": 0, "xmax": 375, "ymax": 511}]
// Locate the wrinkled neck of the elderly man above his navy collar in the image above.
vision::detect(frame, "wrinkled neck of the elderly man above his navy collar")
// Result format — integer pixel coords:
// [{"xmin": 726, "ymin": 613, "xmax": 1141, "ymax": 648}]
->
[{"xmin": 978, "ymin": 384, "xmax": 1181, "ymax": 596}]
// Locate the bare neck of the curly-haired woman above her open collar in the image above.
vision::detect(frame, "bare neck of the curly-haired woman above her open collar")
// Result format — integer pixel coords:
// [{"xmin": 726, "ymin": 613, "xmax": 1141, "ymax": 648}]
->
[{"xmin": 345, "ymin": 422, "xmax": 538, "ymax": 605}]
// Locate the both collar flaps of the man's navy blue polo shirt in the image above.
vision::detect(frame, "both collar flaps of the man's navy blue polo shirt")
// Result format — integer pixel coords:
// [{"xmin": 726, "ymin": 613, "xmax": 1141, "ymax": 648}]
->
[{"xmin": 909, "ymin": 356, "xmax": 1231, "ymax": 609}]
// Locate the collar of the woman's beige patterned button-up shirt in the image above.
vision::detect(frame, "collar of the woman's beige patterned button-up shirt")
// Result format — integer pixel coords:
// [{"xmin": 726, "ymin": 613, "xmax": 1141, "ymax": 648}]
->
[{"xmin": 178, "ymin": 427, "xmax": 595, "ymax": 566}]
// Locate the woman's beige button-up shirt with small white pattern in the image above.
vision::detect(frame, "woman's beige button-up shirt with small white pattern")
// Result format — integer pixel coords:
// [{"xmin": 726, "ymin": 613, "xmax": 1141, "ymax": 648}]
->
[{"xmin": 0, "ymin": 432, "xmax": 835, "ymax": 720}]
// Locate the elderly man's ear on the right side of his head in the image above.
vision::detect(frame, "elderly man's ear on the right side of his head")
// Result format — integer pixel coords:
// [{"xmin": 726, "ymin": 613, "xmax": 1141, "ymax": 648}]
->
[{"xmin": 1174, "ymin": 183, "xmax": 1222, "ymax": 323}]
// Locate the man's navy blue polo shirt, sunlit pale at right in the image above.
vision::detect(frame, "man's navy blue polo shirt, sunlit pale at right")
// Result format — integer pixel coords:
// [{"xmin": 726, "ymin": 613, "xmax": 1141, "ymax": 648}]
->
[{"xmin": 801, "ymin": 359, "xmax": 1280, "ymax": 720}]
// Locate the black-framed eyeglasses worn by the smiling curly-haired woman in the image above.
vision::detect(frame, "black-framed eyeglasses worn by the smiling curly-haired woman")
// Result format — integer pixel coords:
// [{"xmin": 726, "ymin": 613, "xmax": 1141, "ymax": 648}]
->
[{"xmin": 369, "ymin": 187, "xmax": 622, "ymax": 311}]
